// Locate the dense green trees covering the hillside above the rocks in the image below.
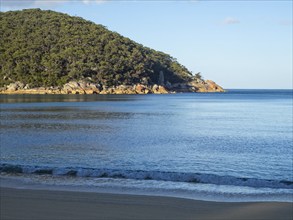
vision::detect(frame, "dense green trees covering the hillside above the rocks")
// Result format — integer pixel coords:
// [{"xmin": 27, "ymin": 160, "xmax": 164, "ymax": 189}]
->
[{"xmin": 0, "ymin": 9, "xmax": 191, "ymax": 87}]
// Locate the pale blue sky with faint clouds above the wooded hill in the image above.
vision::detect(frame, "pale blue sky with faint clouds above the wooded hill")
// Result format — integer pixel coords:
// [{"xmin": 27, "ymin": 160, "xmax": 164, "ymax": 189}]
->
[{"xmin": 0, "ymin": 0, "xmax": 293, "ymax": 89}]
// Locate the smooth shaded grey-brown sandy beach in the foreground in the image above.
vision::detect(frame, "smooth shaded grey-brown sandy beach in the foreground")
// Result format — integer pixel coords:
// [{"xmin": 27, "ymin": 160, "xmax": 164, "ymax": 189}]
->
[{"xmin": 0, "ymin": 187, "xmax": 293, "ymax": 220}]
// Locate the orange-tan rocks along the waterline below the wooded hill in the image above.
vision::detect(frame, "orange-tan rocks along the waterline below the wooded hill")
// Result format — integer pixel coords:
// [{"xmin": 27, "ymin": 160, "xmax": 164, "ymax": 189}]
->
[{"xmin": 0, "ymin": 80, "xmax": 225, "ymax": 94}]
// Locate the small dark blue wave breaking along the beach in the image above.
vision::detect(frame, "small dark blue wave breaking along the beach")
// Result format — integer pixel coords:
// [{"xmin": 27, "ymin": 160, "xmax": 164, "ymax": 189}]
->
[{"xmin": 0, "ymin": 164, "xmax": 293, "ymax": 189}]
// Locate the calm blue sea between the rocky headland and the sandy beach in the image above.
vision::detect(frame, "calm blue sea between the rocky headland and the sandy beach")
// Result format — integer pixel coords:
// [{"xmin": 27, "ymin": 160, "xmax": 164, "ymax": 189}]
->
[{"xmin": 0, "ymin": 90, "xmax": 293, "ymax": 201}]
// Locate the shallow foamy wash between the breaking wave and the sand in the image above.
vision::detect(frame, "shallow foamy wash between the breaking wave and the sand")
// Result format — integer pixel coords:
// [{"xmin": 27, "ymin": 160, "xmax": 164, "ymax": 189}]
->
[{"xmin": 0, "ymin": 174, "xmax": 293, "ymax": 203}]
